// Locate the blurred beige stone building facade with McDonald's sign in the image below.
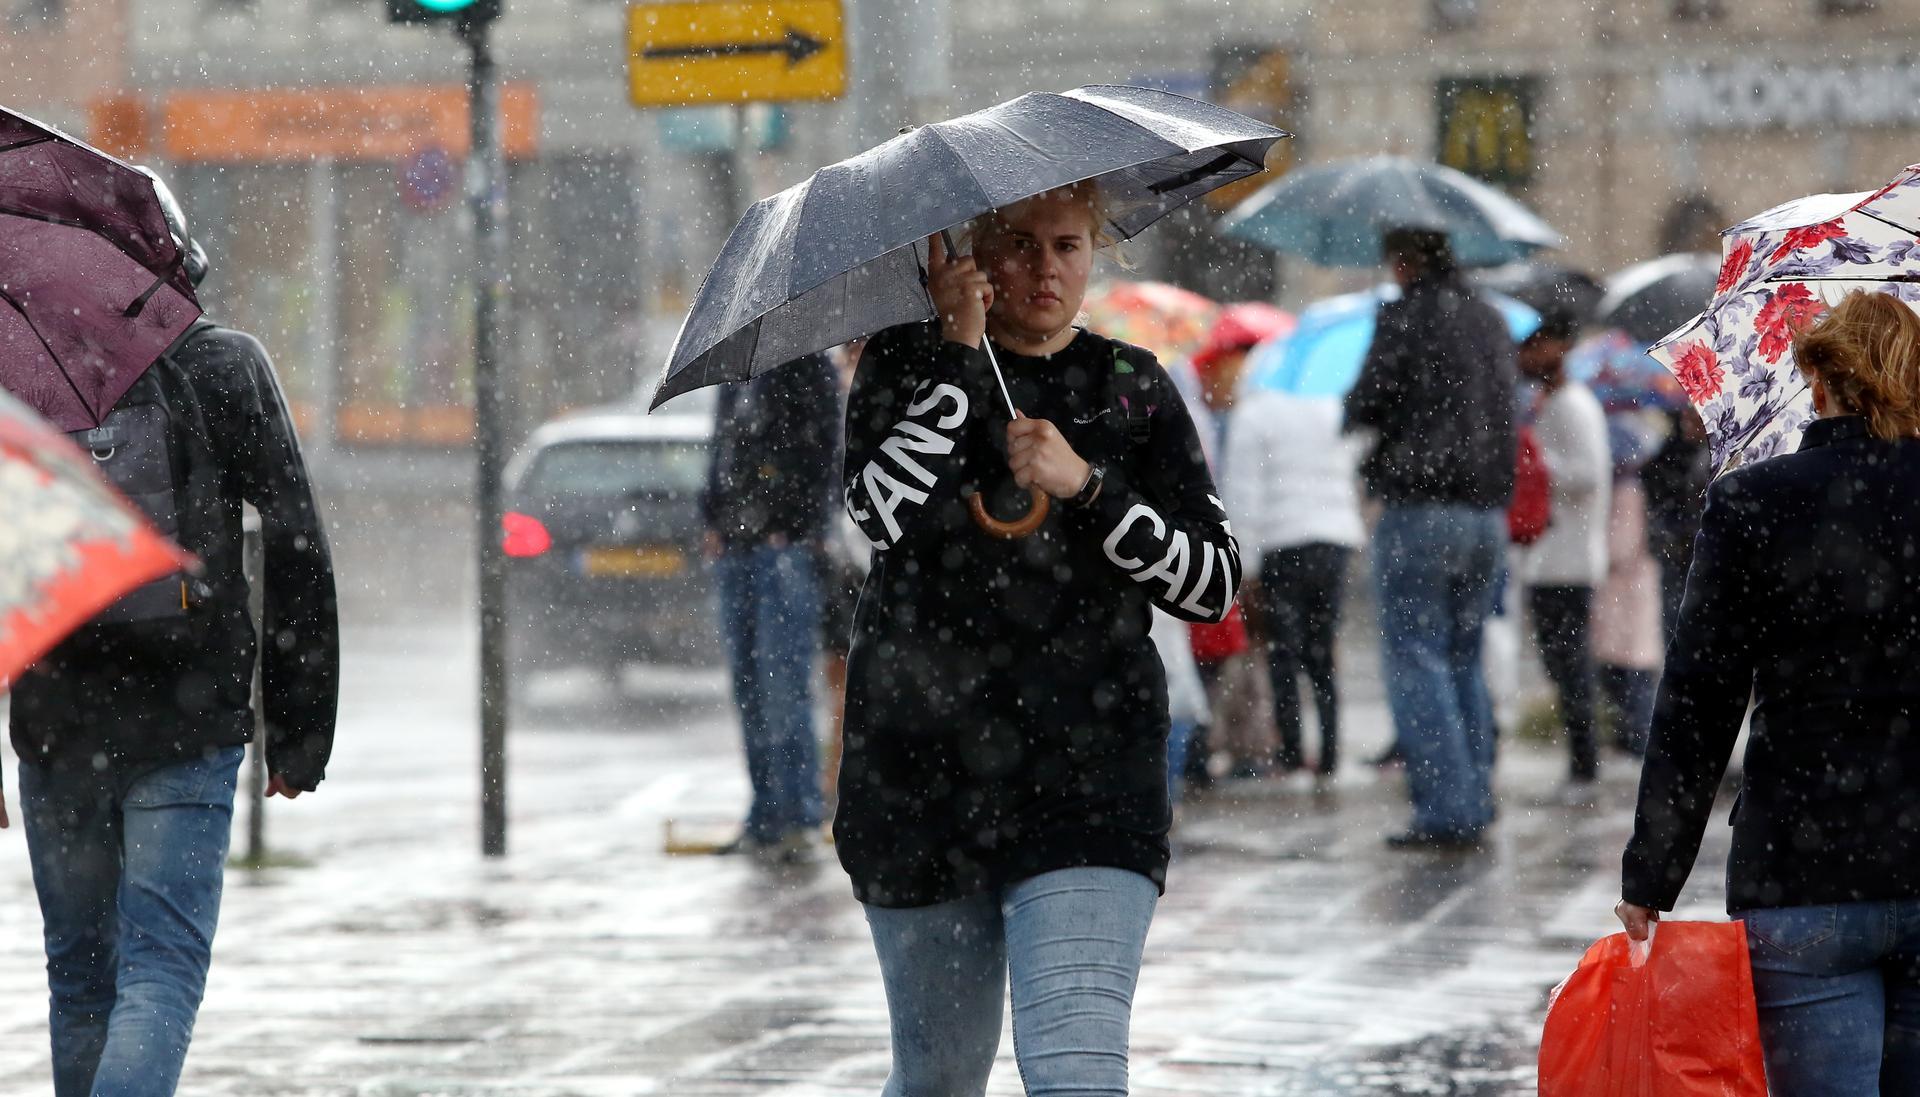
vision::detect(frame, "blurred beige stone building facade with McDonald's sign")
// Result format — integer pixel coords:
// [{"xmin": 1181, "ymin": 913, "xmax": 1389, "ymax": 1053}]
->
[{"xmin": 1300, "ymin": 0, "xmax": 1920, "ymax": 273}]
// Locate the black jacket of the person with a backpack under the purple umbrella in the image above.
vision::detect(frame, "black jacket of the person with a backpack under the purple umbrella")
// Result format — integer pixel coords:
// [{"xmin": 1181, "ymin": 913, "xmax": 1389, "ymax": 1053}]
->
[{"xmin": 12, "ymin": 325, "xmax": 340, "ymax": 790}]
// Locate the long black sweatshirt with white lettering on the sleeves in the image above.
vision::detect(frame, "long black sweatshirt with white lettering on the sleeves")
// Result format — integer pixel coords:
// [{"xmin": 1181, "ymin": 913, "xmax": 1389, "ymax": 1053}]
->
[{"xmin": 833, "ymin": 323, "xmax": 1240, "ymax": 907}]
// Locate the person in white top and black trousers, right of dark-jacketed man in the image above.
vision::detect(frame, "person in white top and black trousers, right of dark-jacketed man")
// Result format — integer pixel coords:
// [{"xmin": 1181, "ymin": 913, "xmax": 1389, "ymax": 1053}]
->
[{"xmin": 1519, "ymin": 309, "xmax": 1613, "ymax": 795}]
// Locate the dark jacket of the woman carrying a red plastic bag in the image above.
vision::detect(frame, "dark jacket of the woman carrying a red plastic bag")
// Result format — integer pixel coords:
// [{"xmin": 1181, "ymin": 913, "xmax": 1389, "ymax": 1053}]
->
[{"xmin": 1620, "ymin": 417, "xmax": 1920, "ymax": 913}]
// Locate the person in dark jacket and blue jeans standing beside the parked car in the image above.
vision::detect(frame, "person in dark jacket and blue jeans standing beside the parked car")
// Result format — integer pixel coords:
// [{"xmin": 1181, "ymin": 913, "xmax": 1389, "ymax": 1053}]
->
[{"xmin": 701, "ymin": 353, "xmax": 839, "ymax": 859}]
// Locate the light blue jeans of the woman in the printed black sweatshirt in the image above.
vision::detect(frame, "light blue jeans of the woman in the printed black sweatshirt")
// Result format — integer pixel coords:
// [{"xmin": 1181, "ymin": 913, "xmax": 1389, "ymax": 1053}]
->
[{"xmin": 866, "ymin": 868, "xmax": 1158, "ymax": 1097}]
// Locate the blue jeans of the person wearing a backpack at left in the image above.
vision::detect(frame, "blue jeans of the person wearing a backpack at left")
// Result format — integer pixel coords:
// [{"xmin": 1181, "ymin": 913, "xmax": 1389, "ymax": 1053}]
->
[{"xmin": 19, "ymin": 747, "xmax": 246, "ymax": 1097}]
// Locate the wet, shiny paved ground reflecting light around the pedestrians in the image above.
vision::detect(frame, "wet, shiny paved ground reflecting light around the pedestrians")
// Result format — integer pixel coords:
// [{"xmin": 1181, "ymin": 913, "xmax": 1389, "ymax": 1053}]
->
[{"xmin": 0, "ymin": 626, "xmax": 1724, "ymax": 1097}]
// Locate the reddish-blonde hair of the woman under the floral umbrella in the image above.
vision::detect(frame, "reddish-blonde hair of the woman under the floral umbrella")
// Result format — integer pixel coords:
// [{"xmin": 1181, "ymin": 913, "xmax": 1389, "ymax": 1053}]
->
[{"xmin": 1793, "ymin": 290, "xmax": 1920, "ymax": 440}]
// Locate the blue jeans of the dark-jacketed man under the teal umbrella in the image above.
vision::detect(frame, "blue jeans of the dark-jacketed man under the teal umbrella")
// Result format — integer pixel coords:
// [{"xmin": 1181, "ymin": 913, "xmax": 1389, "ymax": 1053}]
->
[{"xmin": 1373, "ymin": 503, "xmax": 1505, "ymax": 836}]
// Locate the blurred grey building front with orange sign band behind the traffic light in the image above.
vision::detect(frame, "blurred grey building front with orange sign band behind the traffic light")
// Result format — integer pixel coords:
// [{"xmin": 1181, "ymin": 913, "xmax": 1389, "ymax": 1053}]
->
[{"xmin": 95, "ymin": 0, "xmax": 871, "ymax": 455}]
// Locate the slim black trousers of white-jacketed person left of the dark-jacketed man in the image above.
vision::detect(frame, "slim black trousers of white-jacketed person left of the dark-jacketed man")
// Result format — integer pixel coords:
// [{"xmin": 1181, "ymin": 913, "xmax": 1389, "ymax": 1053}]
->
[{"xmin": 1260, "ymin": 544, "xmax": 1352, "ymax": 774}]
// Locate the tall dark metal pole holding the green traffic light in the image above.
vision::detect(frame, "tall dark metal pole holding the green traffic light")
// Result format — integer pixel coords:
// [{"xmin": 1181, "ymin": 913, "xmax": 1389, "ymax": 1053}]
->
[{"xmin": 459, "ymin": 12, "xmax": 507, "ymax": 857}]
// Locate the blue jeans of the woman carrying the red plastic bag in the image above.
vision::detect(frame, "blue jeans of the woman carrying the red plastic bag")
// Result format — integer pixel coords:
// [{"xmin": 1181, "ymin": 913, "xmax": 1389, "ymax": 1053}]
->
[{"xmin": 1734, "ymin": 899, "xmax": 1920, "ymax": 1097}]
